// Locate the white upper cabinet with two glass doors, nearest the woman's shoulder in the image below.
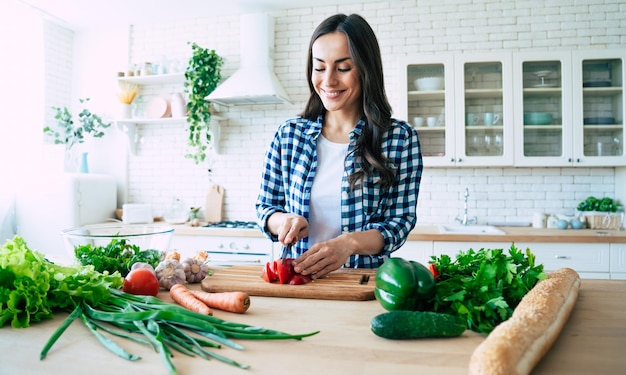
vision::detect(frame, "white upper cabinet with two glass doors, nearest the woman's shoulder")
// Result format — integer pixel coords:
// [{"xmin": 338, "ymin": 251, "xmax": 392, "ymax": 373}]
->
[{"xmin": 399, "ymin": 53, "xmax": 514, "ymax": 166}]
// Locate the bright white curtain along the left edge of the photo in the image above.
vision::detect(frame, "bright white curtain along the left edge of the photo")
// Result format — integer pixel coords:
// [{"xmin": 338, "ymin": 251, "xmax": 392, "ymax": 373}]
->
[{"xmin": 0, "ymin": 0, "xmax": 45, "ymax": 243}]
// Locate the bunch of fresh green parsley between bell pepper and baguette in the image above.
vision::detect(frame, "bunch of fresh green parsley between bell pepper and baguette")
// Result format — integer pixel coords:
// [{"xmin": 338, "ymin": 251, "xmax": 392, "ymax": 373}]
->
[{"xmin": 429, "ymin": 244, "xmax": 547, "ymax": 334}]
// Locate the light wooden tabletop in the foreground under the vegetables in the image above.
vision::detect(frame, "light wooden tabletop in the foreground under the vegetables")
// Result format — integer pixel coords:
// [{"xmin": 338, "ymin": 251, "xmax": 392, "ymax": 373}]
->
[{"xmin": 0, "ymin": 280, "xmax": 626, "ymax": 375}]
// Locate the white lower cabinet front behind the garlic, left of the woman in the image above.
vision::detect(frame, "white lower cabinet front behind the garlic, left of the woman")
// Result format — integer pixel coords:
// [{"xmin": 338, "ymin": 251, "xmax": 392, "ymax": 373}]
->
[{"xmin": 171, "ymin": 235, "xmax": 273, "ymax": 265}]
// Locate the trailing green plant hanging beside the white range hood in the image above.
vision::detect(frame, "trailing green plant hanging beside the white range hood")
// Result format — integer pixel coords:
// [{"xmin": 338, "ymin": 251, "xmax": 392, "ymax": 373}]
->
[{"xmin": 185, "ymin": 43, "xmax": 224, "ymax": 164}]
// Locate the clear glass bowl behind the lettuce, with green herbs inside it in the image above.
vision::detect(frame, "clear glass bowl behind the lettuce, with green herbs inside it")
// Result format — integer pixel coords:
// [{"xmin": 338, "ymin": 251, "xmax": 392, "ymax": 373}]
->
[{"xmin": 61, "ymin": 224, "xmax": 174, "ymax": 259}]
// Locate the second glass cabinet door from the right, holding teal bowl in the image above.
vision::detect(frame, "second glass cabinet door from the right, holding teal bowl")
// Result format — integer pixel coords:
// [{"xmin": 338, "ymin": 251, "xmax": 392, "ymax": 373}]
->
[{"xmin": 515, "ymin": 54, "xmax": 573, "ymax": 166}]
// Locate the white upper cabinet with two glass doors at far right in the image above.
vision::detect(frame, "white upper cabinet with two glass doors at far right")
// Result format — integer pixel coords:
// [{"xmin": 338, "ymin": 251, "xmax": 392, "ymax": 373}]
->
[{"xmin": 513, "ymin": 51, "xmax": 626, "ymax": 167}]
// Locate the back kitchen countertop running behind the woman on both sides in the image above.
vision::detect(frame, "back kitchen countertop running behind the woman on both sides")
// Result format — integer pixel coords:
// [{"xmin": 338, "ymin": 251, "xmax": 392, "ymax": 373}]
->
[{"xmin": 168, "ymin": 225, "xmax": 626, "ymax": 243}]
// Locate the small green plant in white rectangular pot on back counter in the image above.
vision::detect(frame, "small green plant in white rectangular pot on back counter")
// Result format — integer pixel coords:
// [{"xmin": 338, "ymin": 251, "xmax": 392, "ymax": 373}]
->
[{"xmin": 576, "ymin": 196, "xmax": 624, "ymax": 229}]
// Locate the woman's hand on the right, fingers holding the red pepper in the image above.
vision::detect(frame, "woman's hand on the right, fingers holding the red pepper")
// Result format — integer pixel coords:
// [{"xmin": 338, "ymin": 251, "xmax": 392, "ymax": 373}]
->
[{"xmin": 293, "ymin": 236, "xmax": 352, "ymax": 279}]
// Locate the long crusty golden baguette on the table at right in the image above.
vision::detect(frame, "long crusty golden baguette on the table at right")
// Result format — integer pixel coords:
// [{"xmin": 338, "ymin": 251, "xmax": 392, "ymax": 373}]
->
[{"xmin": 469, "ymin": 268, "xmax": 580, "ymax": 375}]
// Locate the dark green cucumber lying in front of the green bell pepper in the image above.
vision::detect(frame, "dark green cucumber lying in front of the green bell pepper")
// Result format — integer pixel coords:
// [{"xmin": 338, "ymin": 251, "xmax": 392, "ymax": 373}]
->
[{"xmin": 371, "ymin": 310, "xmax": 467, "ymax": 340}]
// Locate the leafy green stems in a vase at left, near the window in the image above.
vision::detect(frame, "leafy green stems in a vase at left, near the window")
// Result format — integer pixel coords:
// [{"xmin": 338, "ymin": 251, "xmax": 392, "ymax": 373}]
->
[{"xmin": 43, "ymin": 98, "xmax": 111, "ymax": 172}]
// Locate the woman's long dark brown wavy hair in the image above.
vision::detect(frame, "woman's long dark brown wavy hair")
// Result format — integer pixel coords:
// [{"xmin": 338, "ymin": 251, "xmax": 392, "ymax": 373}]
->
[{"xmin": 301, "ymin": 14, "xmax": 395, "ymax": 189}]
